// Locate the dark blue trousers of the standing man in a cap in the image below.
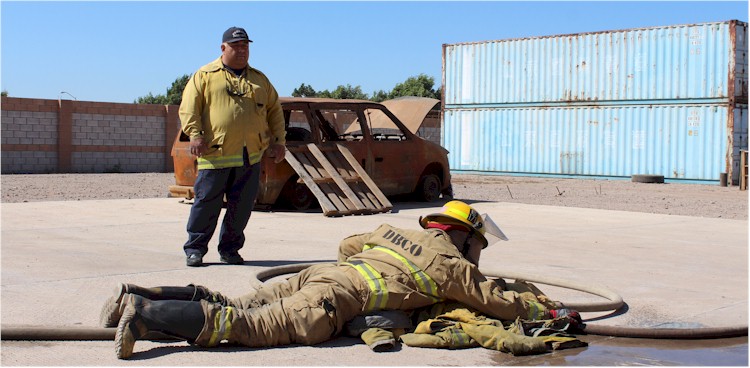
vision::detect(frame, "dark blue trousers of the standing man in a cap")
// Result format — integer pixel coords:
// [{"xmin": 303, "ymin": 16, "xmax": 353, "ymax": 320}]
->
[{"xmin": 183, "ymin": 161, "xmax": 260, "ymax": 257}]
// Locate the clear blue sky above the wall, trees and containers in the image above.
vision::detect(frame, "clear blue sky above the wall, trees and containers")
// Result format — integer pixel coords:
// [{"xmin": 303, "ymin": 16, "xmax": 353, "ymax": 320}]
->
[{"xmin": 0, "ymin": 1, "xmax": 748, "ymax": 103}]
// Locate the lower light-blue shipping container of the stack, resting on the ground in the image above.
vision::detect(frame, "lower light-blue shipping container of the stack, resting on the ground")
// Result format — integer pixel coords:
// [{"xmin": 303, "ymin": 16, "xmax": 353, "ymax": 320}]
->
[{"xmin": 443, "ymin": 105, "xmax": 748, "ymax": 182}]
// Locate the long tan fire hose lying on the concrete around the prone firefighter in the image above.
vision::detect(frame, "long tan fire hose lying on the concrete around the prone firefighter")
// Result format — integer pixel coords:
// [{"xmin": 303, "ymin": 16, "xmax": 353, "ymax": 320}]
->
[{"xmin": 0, "ymin": 263, "xmax": 748, "ymax": 340}]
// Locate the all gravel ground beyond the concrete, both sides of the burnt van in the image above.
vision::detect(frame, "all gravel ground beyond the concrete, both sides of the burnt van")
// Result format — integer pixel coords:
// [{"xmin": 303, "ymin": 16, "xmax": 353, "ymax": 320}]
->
[{"xmin": 0, "ymin": 173, "xmax": 748, "ymax": 220}]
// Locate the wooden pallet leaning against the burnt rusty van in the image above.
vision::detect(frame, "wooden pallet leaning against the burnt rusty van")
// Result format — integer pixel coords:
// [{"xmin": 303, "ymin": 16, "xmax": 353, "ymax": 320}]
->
[{"xmin": 285, "ymin": 143, "xmax": 393, "ymax": 216}]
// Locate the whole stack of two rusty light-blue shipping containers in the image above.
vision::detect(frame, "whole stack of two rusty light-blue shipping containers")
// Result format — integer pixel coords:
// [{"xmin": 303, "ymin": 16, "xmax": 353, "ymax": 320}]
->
[{"xmin": 442, "ymin": 21, "xmax": 748, "ymax": 183}]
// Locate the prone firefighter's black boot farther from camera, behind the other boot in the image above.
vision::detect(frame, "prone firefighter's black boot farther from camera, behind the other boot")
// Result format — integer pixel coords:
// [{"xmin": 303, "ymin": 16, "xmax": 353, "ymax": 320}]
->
[{"xmin": 99, "ymin": 284, "xmax": 228, "ymax": 327}]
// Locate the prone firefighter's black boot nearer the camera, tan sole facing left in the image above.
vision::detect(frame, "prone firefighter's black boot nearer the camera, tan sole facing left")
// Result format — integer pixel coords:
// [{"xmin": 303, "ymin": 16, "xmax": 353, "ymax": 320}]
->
[{"xmin": 115, "ymin": 294, "xmax": 206, "ymax": 359}]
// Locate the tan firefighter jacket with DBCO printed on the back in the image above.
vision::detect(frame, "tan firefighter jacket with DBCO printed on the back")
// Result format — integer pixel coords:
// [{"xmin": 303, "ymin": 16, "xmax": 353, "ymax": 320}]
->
[{"xmin": 338, "ymin": 224, "xmax": 553, "ymax": 320}]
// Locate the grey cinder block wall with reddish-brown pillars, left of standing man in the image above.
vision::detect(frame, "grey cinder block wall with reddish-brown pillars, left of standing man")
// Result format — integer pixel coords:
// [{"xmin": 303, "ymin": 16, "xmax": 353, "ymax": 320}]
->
[{"xmin": 0, "ymin": 97, "xmax": 180, "ymax": 174}]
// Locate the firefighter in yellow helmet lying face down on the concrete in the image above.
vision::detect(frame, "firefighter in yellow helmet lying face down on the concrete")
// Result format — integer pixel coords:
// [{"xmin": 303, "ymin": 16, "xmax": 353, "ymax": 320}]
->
[{"xmin": 101, "ymin": 201, "xmax": 580, "ymax": 359}]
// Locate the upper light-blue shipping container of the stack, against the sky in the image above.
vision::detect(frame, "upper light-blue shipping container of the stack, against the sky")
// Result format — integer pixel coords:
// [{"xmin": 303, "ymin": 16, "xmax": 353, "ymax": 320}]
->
[{"xmin": 443, "ymin": 21, "xmax": 747, "ymax": 106}]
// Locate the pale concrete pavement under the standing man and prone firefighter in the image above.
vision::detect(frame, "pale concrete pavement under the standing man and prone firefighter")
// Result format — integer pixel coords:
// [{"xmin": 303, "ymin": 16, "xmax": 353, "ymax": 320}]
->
[{"xmin": 0, "ymin": 198, "xmax": 748, "ymax": 366}]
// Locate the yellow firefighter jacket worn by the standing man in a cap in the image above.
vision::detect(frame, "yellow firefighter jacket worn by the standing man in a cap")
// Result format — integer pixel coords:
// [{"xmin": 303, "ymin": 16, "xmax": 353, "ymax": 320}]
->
[{"xmin": 179, "ymin": 57, "xmax": 286, "ymax": 170}]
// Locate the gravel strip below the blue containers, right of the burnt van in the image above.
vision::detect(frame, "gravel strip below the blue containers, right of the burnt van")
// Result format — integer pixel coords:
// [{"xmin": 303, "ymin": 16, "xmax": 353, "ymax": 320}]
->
[{"xmin": 453, "ymin": 175, "xmax": 748, "ymax": 220}]
